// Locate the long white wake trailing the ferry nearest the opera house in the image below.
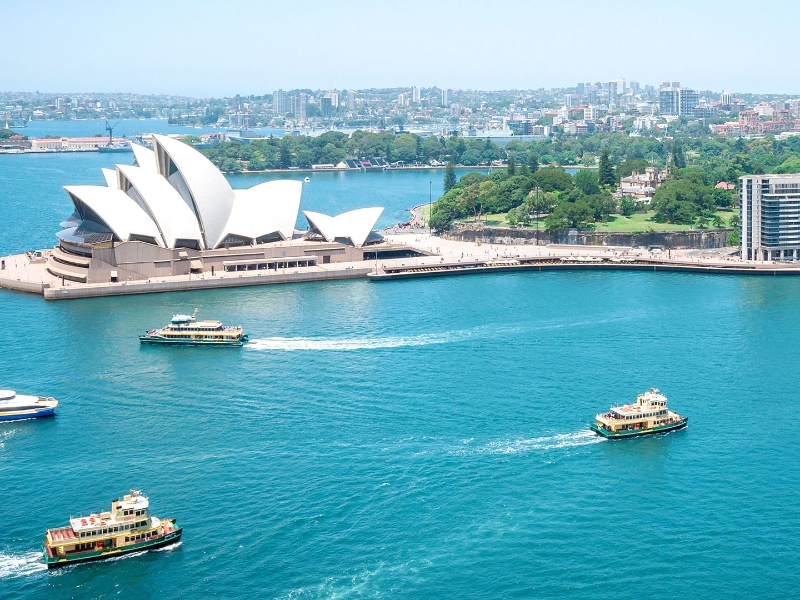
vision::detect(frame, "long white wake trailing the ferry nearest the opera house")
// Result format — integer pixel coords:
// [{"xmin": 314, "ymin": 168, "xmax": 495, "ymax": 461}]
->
[{"xmin": 245, "ymin": 329, "xmax": 486, "ymax": 352}]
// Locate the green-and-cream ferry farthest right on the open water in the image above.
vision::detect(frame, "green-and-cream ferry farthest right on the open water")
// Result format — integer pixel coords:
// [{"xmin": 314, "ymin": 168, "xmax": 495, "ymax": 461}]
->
[{"xmin": 591, "ymin": 388, "xmax": 689, "ymax": 440}]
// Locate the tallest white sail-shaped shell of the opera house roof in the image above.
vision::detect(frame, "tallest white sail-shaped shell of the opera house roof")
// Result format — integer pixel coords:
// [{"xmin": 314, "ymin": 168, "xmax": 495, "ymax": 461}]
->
[{"xmin": 153, "ymin": 135, "xmax": 234, "ymax": 248}]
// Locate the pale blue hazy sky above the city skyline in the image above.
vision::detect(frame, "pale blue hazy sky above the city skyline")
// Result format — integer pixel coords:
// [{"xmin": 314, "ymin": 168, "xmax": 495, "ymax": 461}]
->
[{"xmin": 6, "ymin": 0, "xmax": 800, "ymax": 97}]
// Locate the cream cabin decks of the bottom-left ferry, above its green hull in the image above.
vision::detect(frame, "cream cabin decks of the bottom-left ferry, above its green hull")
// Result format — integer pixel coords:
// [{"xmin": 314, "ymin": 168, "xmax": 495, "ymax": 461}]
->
[{"xmin": 46, "ymin": 492, "xmax": 171, "ymax": 558}]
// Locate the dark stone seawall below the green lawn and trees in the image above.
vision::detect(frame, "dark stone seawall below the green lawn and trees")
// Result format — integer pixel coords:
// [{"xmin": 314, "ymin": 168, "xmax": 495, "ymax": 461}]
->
[{"xmin": 441, "ymin": 224, "xmax": 733, "ymax": 249}]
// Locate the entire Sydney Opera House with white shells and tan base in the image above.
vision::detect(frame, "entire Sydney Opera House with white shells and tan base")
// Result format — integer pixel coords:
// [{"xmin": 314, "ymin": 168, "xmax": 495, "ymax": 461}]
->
[{"xmin": 47, "ymin": 135, "xmax": 406, "ymax": 283}]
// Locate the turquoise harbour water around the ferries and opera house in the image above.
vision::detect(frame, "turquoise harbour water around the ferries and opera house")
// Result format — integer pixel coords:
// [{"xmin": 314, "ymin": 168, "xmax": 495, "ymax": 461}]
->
[{"xmin": 0, "ymin": 155, "xmax": 800, "ymax": 599}]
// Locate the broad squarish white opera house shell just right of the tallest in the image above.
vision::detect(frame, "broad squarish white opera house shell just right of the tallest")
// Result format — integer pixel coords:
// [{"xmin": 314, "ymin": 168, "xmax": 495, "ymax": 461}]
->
[{"xmin": 223, "ymin": 179, "xmax": 303, "ymax": 240}]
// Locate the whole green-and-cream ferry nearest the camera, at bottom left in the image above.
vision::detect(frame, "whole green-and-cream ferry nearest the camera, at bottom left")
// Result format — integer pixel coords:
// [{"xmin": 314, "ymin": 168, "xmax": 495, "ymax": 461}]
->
[{"xmin": 43, "ymin": 490, "xmax": 183, "ymax": 569}]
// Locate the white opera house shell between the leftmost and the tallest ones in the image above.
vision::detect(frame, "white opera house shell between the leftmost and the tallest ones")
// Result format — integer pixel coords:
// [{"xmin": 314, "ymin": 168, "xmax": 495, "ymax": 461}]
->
[{"xmin": 117, "ymin": 163, "xmax": 204, "ymax": 250}]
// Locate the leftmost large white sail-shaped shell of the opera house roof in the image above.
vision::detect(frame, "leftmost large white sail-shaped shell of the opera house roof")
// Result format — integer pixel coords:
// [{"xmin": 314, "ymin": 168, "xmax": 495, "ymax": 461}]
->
[{"xmin": 64, "ymin": 185, "xmax": 164, "ymax": 246}]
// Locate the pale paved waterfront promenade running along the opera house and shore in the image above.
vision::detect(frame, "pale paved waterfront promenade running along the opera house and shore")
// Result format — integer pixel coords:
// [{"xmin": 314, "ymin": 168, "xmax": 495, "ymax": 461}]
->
[{"xmin": 0, "ymin": 230, "xmax": 800, "ymax": 300}]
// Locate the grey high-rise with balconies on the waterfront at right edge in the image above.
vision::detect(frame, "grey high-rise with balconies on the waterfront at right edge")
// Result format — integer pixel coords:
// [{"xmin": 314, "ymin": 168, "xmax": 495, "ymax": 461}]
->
[{"xmin": 739, "ymin": 173, "xmax": 800, "ymax": 260}]
